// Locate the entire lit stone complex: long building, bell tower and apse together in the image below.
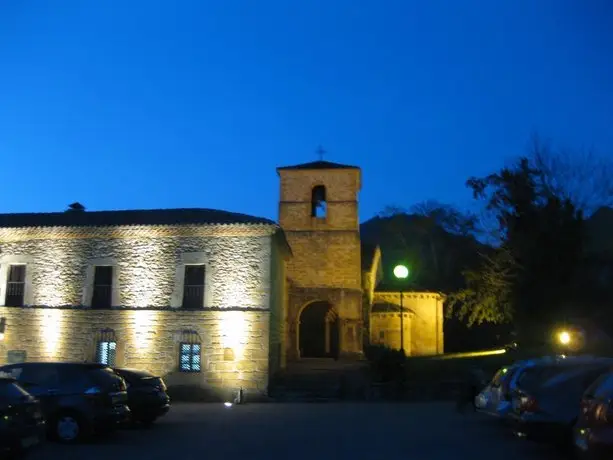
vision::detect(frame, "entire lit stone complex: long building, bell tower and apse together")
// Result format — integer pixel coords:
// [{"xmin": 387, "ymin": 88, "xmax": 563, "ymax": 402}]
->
[{"xmin": 0, "ymin": 161, "xmax": 443, "ymax": 397}]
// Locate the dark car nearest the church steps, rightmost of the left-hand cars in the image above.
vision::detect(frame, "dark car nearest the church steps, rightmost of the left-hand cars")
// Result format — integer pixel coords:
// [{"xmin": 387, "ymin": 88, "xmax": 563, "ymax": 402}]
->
[{"xmin": 115, "ymin": 369, "xmax": 170, "ymax": 425}]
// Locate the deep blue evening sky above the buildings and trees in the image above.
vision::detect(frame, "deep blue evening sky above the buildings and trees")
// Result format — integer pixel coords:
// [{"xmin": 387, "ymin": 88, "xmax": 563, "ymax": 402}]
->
[{"xmin": 0, "ymin": 0, "xmax": 613, "ymax": 220}]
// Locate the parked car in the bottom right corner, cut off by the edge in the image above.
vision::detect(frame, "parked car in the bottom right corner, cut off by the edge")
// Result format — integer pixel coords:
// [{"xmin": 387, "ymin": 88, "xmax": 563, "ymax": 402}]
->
[{"xmin": 574, "ymin": 371, "xmax": 613, "ymax": 459}]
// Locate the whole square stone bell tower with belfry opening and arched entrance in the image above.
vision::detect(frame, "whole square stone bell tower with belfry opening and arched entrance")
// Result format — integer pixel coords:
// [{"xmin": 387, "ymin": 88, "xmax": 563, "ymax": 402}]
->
[{"xmin": 277, "ymin": 160, "xmax": 363, "ymax": 359}]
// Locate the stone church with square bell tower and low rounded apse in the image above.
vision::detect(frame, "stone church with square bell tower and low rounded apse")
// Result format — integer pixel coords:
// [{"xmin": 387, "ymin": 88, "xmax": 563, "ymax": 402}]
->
[{"xmin": 277, "ymin": 161, "xmax": 443, "ymax": 360}]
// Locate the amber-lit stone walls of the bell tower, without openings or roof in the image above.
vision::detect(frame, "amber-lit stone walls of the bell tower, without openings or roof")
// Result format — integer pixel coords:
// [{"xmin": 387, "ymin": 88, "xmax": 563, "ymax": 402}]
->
[{"xmin": 279, "ymin": 169, "xmax": 363, "ymax": 359}]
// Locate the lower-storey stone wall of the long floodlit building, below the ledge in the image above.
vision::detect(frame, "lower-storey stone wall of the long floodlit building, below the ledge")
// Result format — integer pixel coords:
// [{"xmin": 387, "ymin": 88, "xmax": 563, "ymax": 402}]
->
[{"xmin": 0, "ymin": 307, "xmax": 270, "ymax": 397}]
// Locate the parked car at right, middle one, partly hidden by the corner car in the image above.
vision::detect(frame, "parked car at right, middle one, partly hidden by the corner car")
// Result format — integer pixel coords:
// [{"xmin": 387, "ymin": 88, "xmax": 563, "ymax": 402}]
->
[{"xmin": 509, "ymin": 358, "xmax": 613, "ymax": 444}]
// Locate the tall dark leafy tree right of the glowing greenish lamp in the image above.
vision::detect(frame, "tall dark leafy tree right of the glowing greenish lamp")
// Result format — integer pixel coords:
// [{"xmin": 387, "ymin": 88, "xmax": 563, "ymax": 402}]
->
[{"xmin": 448, "ymin": 144, "xmax": 596, "ymax": 340}]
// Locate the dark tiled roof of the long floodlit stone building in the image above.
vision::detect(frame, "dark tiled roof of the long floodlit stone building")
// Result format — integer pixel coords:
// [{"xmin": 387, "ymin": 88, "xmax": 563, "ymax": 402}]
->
[{"xmin": 0, "ymin": 208, "xmax": 276, "ymax": 228}]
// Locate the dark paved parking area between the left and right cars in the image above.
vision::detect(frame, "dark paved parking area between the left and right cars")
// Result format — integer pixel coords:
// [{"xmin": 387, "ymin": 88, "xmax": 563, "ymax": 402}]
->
[{"xmin": 31, "ymin": 403, "xmax": 556, "ymax": 460}]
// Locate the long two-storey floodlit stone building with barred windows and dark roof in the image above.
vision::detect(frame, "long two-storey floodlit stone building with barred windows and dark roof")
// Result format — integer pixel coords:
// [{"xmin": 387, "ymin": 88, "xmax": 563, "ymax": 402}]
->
[{"xmin": 0, "ymin": 208, "xmax": 290, "ymax": 393}]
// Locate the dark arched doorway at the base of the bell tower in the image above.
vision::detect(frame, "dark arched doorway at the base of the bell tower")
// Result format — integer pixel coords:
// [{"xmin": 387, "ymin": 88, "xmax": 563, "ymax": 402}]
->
[{"xmin": 298, "ymin": 302, "xmax": 339, "ymax": 358}]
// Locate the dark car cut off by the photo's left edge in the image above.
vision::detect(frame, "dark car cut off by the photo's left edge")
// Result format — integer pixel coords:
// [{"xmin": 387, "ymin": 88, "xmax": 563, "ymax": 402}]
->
[{"xmin": 0, "ymin": 377, "xmax": 45, "ymax": 458}]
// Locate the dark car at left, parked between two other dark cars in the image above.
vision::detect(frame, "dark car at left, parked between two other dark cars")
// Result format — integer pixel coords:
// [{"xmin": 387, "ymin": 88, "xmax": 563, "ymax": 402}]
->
[{"xmin": 0, "ymin": 363, "xmax": 130, "ymax": 443}]
